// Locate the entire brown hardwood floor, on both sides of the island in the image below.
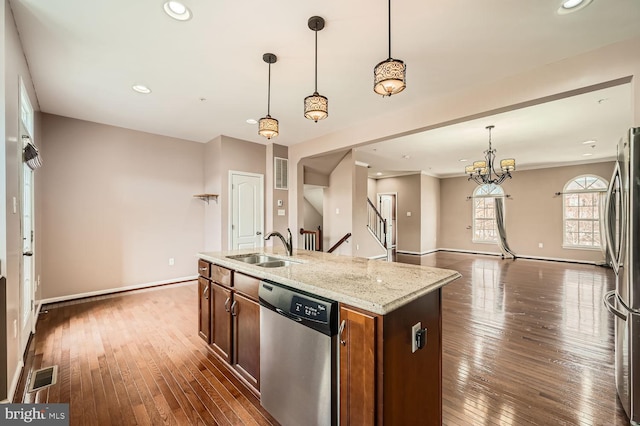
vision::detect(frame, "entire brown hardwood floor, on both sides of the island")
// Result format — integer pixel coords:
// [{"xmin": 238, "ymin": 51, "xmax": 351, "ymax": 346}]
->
[{"xmin": 16, "ymin": 253, "xmax": 628, "ymax": 426}]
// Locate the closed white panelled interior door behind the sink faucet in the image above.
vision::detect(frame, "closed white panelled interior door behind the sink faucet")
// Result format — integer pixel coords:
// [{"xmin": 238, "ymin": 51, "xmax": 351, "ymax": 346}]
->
[{"xmin": 229, "ymin": 172, "xmax": 264, "ymax": 250}]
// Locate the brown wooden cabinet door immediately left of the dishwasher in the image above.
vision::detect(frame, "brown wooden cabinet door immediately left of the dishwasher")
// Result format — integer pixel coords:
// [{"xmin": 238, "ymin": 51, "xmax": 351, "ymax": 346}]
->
[{"xmin": 231, "ymin": 293, "xmax": 260, "ymax": 390}]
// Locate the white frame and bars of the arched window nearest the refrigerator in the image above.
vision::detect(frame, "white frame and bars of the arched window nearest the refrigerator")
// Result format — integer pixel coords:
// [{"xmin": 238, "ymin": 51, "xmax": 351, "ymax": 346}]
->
[{"xmin": 562, "ymin": 174, "xmax": 609, "ymax": 250}]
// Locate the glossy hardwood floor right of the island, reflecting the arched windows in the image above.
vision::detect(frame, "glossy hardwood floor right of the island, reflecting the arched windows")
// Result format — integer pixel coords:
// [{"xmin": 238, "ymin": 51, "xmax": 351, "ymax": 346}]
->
[{"xmin": 399, "ymin": 252, "xmax": 629, "ymax": 425}]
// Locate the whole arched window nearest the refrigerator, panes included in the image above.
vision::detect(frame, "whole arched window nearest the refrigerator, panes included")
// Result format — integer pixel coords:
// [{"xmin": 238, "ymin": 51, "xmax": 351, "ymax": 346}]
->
[{"xmin": 562, "ymin": 175, "xmax": 608, "ymax": 249}]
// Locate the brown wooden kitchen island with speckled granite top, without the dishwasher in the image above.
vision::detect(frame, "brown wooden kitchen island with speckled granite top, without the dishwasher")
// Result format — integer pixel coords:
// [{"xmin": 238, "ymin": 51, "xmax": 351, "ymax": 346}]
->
[{"xmin": 198, "ymin": 248, "xmax": 460, "ymax": 425}]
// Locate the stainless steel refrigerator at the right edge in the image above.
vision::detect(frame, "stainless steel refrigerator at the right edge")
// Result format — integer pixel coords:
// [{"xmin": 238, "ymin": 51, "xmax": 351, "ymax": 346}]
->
[{"xmin": 604, "ymin": 127, "xmax": 640, "ymax": 425}]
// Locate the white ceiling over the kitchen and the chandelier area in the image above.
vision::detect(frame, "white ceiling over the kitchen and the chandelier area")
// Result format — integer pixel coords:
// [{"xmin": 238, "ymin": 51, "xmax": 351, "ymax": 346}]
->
[{"xmin": 10, "ymin": 0, "xmax": 640, "ymax": 175}]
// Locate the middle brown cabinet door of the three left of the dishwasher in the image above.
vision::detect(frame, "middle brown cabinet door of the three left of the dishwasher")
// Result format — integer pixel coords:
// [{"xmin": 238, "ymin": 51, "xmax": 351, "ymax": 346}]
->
[{"xmin": 210, "ymin": 282, "xmax": 232, "ymax": 363}]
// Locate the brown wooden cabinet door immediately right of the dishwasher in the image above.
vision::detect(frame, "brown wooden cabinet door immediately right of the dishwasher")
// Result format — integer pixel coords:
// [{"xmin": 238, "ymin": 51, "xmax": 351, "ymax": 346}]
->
[{"xmin": 340, "ymin": 306, "xmax": 376, "ymax": 426}]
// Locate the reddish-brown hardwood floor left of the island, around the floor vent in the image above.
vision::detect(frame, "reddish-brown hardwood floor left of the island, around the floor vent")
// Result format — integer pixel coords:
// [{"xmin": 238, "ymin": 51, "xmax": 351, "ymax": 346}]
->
[{"xmin": 16, "ymin": 281, "xmax": 276, "ymax": 426}]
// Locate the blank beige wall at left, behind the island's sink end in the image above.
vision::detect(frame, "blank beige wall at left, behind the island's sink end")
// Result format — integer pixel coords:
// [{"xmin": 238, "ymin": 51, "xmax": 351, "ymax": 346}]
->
[{"xmin": 41, "ymin": 114, "xmax": 205, "ymax": 299}]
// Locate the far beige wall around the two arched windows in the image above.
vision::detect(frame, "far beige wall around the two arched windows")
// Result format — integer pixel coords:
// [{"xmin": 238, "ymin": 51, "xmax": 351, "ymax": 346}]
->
[{"xmin": 439, "ymin": 162, "xmax": 613, "ymax": 262}]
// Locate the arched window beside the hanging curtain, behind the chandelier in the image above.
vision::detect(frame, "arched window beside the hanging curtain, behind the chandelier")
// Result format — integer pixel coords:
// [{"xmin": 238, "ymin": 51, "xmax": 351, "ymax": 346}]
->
[{"xmin": 473, "ymin": 184, "xmax": 504, "ymax": 243}]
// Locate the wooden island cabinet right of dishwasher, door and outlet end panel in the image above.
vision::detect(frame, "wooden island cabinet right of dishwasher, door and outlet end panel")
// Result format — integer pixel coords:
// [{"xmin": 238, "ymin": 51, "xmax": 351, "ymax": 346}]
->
[{"xmin": 340, "ymin": 289, "xmax": 442, "ymax": 426}]
